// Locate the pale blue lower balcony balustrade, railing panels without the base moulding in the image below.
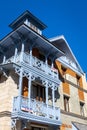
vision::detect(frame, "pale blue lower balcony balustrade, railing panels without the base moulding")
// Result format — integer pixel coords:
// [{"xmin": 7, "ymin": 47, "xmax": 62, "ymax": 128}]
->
[{"xmin": 12, "ymin": 96, "xmax": 60, "ymax": 121}]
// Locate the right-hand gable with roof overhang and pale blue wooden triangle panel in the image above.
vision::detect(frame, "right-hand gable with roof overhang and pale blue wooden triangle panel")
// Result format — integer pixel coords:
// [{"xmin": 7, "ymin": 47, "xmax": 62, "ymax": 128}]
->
[{"xmin": 50, "ymin": 36, "xmax": 84, "ymax": 75}]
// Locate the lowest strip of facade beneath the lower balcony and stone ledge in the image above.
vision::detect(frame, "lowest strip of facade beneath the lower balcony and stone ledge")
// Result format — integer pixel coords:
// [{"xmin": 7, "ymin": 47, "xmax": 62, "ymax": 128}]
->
[{"xmin": 0, "ymin": 112, "xmax": 87, "ymax": 130}]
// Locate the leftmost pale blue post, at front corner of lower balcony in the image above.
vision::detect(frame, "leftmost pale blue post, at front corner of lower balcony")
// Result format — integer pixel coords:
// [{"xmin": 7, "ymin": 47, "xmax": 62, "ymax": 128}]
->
[{"xmin": 19, "ymin": 68, "xmax": 23, "ymax": 111}]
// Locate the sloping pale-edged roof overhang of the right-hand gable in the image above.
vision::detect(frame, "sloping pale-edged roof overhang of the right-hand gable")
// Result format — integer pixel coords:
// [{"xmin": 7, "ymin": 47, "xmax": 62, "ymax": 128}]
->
[{"xmin": 50, "ymin": 35, "xmax": 84, "ymax": 74}]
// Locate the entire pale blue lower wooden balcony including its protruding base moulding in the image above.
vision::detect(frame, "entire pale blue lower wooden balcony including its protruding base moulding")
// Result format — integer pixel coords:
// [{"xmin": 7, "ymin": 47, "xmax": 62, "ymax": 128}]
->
[{"xmin": 12, "ymin": 96, "xmax": 61, "ymax": 125}]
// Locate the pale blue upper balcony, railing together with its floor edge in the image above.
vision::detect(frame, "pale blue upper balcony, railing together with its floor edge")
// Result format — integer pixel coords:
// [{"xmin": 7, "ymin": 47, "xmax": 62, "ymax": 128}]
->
[{"xmin": 5, "ymin": 52, "xmax": 60, "ymax": 86}]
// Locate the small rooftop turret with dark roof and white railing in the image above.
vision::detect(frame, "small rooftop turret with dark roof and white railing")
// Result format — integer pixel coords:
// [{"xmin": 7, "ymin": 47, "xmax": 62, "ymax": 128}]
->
[{"xmin": 9, "ymin": 11, "xmax": 47, "ymax": 35}]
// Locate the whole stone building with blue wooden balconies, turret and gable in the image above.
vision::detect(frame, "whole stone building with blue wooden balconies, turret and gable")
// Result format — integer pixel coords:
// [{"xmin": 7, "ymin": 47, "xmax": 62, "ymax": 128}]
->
[{"xmin": 0, "ymin": 11, "xmax": 87, "ymax": 130}]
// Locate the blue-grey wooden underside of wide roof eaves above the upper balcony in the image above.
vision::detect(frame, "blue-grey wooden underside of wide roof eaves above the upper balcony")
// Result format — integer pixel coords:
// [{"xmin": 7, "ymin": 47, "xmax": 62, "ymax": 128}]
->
[{"xmin": 0, "ymin": 24, "xmax": 64, "ymax": 59}]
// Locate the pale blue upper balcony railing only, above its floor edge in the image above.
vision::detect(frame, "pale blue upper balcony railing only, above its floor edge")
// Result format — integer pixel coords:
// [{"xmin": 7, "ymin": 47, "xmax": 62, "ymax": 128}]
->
[{"xmin": 5, "ymin": 53, "xmax": 58, "ymax": 79}]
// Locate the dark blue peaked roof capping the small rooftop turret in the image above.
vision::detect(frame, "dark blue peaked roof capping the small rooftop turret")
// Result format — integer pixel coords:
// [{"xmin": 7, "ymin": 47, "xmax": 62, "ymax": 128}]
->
[{"xmin": 9, "ymin": 10, "xmax": 47, "ymax": 30}]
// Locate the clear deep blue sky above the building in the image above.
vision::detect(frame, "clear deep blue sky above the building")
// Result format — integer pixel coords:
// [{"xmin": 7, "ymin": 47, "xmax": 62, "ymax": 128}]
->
[{"xmin": 0, "ymin": 0, "xmax": 87, "ymax": 72}]
